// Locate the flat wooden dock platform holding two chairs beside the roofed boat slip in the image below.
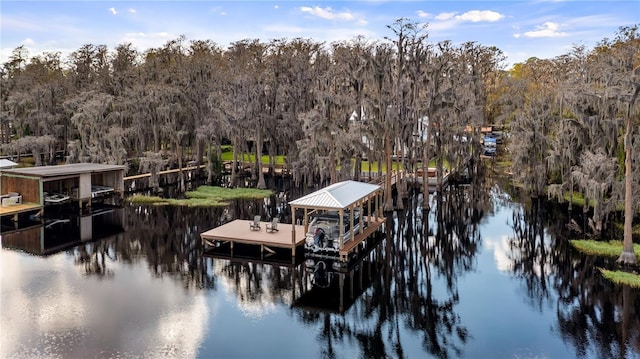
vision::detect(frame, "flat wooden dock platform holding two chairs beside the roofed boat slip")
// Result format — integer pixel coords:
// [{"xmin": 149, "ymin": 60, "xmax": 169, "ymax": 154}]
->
[{"xmin": 200, "ymin": 219, "xmax": 305, "ymax": 257}]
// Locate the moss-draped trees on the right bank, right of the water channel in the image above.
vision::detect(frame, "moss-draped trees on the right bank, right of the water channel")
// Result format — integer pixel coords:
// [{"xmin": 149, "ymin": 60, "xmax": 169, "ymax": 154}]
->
[{"xmin": 502, "ymin": 25, "xmax": 640, "ymax": 263}]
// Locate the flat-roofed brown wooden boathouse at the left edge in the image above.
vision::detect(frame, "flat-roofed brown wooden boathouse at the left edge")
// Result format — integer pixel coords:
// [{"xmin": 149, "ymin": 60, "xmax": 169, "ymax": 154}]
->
[{"xmin": 0, "ymin": 163, "xmax": 126, "ymax": 219}]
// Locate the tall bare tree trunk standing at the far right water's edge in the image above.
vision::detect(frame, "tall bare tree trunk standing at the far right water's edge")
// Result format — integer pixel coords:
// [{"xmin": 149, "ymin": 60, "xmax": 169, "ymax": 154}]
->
[{"xmin": 618, "ymin": 116, "xmax": 638, "ymax": 265}]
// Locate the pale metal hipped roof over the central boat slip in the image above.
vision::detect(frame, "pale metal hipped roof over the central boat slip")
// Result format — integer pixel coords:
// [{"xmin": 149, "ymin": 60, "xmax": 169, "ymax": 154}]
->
[{"xmin": 289, "ymin": 181, "xmax": 382, "ymax": 209}]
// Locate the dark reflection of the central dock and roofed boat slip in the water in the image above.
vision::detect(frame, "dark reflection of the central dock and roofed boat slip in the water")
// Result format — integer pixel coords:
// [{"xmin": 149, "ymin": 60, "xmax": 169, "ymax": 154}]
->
[{"xmin": 203, "ymin": 232, "xmax": 385, "ymax": 314}]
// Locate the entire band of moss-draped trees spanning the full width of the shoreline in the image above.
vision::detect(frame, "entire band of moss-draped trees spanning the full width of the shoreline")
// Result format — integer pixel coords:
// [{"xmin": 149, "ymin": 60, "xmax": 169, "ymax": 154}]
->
[{"xmin": 0, "ymin": 19, "xmax": 640, "ymax": 261}]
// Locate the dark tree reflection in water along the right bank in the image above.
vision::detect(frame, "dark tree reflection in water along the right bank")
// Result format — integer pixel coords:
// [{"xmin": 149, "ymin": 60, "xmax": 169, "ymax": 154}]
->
[{"xmin": 509, "ymin": 199, "xmax": 640, "ymax": 358}]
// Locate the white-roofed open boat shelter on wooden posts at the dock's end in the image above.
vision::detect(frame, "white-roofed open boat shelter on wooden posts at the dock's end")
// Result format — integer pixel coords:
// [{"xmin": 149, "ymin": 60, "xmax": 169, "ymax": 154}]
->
[{"xmin": 289, "ymin": 180, "xmax": 385, "ymax": 262}]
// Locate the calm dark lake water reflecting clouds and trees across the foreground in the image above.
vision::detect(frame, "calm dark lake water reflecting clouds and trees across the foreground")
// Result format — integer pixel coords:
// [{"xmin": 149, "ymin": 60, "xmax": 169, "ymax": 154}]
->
[{"xmin": 0, "ymin": 187, "xmax": 640, "ymax": 358}]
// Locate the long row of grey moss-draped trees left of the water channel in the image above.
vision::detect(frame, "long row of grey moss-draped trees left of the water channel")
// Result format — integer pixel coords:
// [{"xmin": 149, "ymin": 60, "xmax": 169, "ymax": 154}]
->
[{"xmin": 0, "ymin": 19, "xmax": 502, "ymax": 208}]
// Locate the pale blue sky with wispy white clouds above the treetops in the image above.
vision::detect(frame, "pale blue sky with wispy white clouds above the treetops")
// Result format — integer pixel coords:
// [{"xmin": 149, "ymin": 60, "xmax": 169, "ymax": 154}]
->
[{"xmin": 0, "ymin": 0, "xmax": 640, "ymax": 65}]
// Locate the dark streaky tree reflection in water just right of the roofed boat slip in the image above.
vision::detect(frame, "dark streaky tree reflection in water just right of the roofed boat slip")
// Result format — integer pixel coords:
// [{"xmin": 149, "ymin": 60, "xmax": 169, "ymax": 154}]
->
[{"xmin": 292, "ymin": 177, "xmax": 490, "ymax": 358}]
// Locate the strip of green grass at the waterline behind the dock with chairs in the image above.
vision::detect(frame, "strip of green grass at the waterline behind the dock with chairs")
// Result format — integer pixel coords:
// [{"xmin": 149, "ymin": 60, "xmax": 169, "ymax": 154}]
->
[{"xmin": 129, "ymin": 186, "xmax": 273, "ymax": 207}]
